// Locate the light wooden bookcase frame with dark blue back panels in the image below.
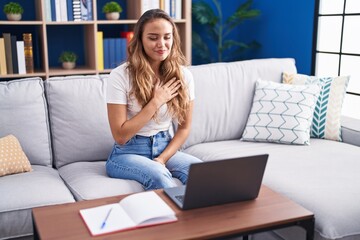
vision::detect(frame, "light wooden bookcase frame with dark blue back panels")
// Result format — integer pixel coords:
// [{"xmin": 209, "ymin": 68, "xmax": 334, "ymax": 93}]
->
[{"xmin": 0, "ymin": 0, "xmax": 191, "ymax": 81}]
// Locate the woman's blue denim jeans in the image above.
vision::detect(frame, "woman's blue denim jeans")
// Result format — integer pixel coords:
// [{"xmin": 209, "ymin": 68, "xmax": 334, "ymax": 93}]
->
[{"xmin": 106, "ymin": 131, "xmax": 201, "ymax": 190}]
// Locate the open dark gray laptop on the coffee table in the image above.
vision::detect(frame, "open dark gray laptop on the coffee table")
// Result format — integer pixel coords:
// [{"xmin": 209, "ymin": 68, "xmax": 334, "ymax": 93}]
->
[{"xmin": 164, "ymin": 154, "xmax": 269, "ymax": 210}]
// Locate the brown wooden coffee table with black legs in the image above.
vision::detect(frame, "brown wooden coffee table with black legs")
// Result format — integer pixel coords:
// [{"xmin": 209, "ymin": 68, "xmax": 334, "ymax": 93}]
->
[{"xmin": 32, "ymin": 186, "xmax": 314, "ymax": 240}]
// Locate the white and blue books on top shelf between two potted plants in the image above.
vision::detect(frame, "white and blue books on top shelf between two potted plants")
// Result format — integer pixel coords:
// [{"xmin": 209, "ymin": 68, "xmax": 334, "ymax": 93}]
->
[{"xmin": 44, "ymin": 0, "xmax": 93, "ymax": 22}]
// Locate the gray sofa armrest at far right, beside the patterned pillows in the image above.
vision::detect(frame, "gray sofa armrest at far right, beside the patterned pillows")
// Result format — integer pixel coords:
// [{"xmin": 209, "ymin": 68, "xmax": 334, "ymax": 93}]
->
[{"xmin": 341, "ymin": 116, "xmax": 360, "ymax": 147}]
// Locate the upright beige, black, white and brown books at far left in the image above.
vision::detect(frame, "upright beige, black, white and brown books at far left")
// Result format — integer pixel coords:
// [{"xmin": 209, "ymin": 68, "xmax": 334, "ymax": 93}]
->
[{"xmin": 0, "ymin": 33, "xmax": 33, "ymax": 75}]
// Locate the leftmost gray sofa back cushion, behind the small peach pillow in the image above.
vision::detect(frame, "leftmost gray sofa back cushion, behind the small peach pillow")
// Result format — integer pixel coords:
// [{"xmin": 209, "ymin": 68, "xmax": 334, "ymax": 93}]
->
[{"xmin": 0, "ymin": 78, "xmax": 52, "ymax": 166}]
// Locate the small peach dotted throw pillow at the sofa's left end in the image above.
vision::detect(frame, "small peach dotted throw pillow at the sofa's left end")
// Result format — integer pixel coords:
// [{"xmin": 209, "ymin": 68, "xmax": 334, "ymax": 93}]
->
[{"xmin": 0, "ymin": 135, "xmax": 32, "ymax": 177}]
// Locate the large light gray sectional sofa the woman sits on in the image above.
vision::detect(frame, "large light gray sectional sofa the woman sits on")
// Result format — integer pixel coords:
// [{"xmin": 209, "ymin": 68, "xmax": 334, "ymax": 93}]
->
[{"xmin": 0, "ymin": 59, "xmax": 360, "ymax": 240}]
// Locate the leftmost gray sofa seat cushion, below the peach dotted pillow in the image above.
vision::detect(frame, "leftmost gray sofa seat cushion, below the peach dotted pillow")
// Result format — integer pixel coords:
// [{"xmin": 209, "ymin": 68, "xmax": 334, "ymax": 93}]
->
[{"xmin": 0, "ymin": 165, "xmax": 75, "ymax": 239}]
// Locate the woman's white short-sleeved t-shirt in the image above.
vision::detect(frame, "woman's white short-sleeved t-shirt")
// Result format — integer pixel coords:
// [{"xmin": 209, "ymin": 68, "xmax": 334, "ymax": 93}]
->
[{"xmin": 106, "ymin": 63, "xmax": 195, "ymax": 136}]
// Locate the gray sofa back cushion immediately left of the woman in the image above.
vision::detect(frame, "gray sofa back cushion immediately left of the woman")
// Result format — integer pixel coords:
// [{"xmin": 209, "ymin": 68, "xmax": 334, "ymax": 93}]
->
[{"xmin": 45, "ymin": 75, "xmax": 114, "ymax": 168}]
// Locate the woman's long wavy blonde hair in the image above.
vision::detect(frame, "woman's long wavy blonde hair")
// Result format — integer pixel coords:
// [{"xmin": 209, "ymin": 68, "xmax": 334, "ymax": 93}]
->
[{"xmin": 127, "ymin": 9, "xmax": 190, "ymax": 124}]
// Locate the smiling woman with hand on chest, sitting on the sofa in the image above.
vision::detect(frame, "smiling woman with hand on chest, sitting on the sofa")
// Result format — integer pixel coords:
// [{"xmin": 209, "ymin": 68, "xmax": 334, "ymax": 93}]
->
[{"xmin": 106, "ymin": 9, "xmax": 200, "ymax": 190}]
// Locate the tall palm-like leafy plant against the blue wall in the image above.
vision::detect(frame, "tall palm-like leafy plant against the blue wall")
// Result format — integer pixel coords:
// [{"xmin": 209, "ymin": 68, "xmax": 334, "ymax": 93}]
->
[{"xmin": 192, "ymin": 0, "xmax": 260, "ymax": 63}]
